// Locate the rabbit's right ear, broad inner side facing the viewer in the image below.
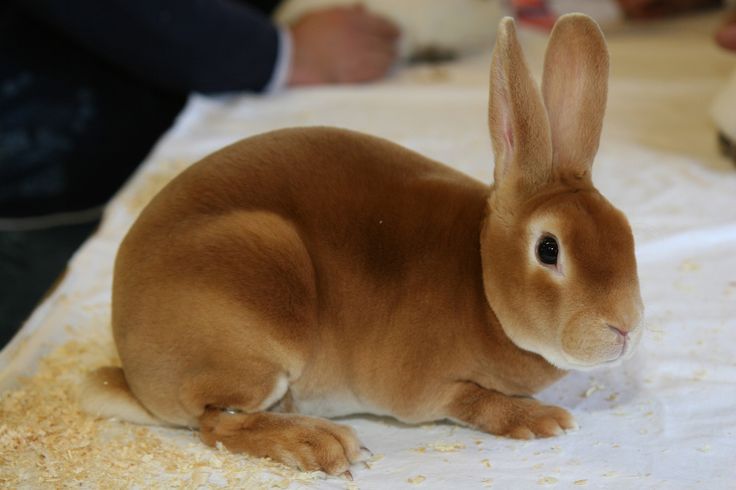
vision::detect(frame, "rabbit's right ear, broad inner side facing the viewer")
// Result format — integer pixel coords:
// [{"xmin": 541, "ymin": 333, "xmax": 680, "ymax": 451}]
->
[{"xmin": 542, "ymin": 14, "xmax": 608, "ymax": 177}]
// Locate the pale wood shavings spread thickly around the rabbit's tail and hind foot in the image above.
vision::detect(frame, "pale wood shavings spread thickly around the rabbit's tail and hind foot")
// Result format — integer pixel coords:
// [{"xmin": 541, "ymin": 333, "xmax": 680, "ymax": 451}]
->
[{"xmin": 0, "ymin": 335, "xmax": 322, "ymax": 489}]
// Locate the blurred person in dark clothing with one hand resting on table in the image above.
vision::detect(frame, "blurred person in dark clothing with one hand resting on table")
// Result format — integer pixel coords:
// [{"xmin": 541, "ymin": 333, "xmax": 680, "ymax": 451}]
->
[{"xmin": 0, "ymin": 0, "xmax": 399, "ymax": 347}]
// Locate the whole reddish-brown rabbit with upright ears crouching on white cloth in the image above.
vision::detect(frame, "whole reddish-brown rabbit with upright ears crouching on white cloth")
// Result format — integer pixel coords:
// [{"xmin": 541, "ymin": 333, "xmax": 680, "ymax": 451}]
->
[{"xmin": 83, "ymin": 15, "xmax": 643, "ymax": 474}]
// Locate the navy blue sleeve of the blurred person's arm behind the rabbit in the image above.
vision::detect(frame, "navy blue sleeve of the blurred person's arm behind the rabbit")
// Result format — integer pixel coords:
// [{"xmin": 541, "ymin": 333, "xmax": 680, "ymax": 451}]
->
[{"xmin": 17, "ymin": 0, "xmax": 279, "ymax": 93}]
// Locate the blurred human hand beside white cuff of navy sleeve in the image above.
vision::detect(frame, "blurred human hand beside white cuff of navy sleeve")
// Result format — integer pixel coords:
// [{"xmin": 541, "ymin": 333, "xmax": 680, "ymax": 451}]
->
[{"xmin": 288, "ymin": 6, "xmax": 399, "ymax": 85}]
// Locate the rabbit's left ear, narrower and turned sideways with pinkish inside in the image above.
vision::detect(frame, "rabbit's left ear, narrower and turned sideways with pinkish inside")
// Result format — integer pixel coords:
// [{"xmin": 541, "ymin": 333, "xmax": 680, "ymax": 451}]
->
[{"xmin": 488, "ymin": 17, "xmax": 552, "ymax": 195}]
